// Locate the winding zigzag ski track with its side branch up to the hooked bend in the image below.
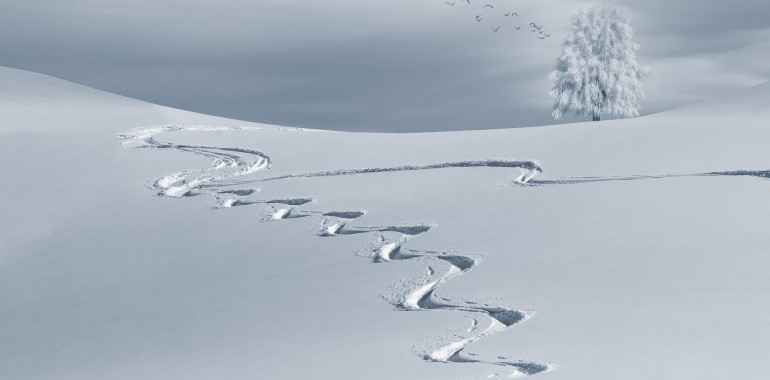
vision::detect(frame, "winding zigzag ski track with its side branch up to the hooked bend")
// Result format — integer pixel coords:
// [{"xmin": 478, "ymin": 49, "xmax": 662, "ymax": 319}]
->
[{"xmin": 119, "ymin": 126, "xmax": 554, "ymax": 377}]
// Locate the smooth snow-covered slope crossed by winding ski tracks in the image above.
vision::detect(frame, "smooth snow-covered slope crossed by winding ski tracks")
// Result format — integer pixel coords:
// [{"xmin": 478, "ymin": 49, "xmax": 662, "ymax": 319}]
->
[{"xmin": 0, "ymin": 69, "xmax": 770, "ymax": 380}]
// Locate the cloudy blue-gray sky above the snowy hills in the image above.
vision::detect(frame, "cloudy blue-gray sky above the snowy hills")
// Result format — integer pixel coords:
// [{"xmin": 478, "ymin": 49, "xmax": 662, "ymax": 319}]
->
[{"xmin": 0, "ymin": 0, "xmax": 770, "ymax": 132}]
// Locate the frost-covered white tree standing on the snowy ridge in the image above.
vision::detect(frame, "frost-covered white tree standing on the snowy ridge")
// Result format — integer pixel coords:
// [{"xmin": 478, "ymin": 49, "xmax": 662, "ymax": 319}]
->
[{"xmin": 550, "ymin": 5, "xmax": 650, "ymax": 121}]
